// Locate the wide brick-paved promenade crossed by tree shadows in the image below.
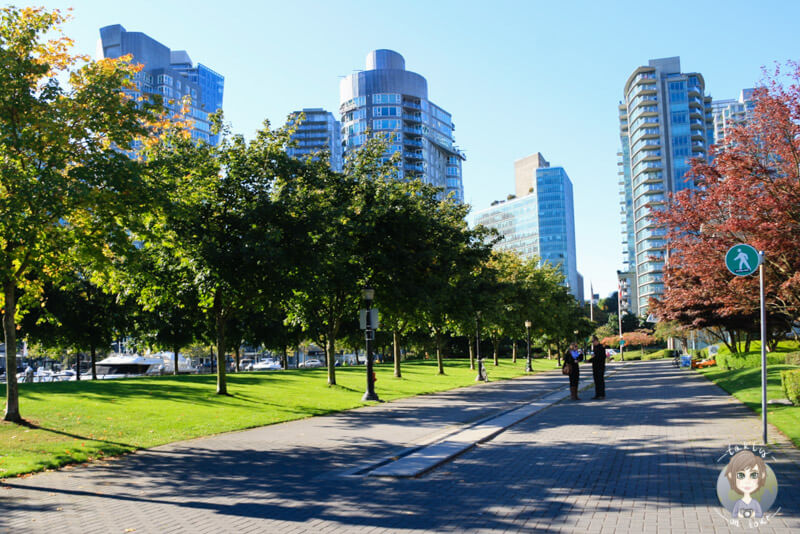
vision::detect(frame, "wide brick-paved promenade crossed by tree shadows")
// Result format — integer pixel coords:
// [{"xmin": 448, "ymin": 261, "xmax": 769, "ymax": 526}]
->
[{"xmin": 0, "ymin": 361, "xmax": 800, "ymax": 534}]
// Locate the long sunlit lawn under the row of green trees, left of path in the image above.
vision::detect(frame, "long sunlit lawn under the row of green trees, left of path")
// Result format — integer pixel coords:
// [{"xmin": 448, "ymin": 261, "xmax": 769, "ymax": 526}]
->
[{"xmin": 0, "ymin": 358, "xmax": 557, "ymax": 477}]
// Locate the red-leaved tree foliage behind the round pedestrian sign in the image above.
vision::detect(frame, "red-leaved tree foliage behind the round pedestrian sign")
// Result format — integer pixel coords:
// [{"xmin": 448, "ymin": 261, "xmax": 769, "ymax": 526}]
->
[{"xmin": 651, "ymin": 63, "xmax": 800, "ymax": 340}]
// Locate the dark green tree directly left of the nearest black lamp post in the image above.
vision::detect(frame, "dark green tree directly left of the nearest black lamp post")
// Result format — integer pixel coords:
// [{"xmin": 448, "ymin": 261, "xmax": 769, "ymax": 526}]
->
[{"xmin": 286, "ymin": 139, "xmax": 395, "ymax": 385}]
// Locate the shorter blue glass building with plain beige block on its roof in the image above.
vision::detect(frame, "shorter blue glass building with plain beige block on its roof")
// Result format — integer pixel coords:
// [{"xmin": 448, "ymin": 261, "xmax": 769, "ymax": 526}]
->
[{"xmin": 473, "ymin": 153, "xmax": 583, "ymax": 302}]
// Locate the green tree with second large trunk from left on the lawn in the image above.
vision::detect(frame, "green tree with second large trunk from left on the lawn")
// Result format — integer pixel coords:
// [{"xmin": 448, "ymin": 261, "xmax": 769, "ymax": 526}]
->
[{"xmin": 136, "ymin": 121, "xmax": 296, "ymax": 395}]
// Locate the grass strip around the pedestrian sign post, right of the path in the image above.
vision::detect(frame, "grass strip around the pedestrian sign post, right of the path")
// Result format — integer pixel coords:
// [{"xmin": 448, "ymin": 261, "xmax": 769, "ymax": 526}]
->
[{"xmin": 699, "ymin": 365, "xmax": 800, "ymax": 447}]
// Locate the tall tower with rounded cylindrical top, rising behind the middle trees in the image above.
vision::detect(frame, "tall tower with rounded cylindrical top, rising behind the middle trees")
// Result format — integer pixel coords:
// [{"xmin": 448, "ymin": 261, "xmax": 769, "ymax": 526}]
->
[{"xmin": 339, "ymin": 50, "xmax": 466, "ymax": 202}]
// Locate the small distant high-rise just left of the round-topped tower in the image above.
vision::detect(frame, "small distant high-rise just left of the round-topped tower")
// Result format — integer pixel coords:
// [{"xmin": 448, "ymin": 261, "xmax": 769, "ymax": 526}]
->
[{"xmin": 287, "ymin": 108, "xmax": 342, "ymax": 172}]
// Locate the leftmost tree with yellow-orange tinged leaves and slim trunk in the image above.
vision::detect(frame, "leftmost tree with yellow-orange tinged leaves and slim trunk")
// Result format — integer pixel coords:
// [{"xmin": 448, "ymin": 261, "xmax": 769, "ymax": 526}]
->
[{"xmin": 0, "ymin": 7, "xmax": 159, "ymax": 422}]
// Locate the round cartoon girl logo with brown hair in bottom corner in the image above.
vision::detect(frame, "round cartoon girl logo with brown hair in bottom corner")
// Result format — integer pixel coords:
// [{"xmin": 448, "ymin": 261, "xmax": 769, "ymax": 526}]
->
[{"xmin": 717, "ymin": 450, "xmax": 778, "ymax": 519}]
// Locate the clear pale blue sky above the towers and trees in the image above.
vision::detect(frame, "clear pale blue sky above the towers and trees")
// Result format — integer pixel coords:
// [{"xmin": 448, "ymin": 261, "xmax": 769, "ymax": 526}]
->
[{"xmin": 37, "ymin": 0, "xmax": 800, "ymax": 297}]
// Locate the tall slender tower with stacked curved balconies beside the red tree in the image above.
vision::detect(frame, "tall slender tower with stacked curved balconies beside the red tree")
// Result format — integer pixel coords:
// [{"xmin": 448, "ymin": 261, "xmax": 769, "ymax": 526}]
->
[{"xmin": 619, "ymin": 57, "xmax": 714, "ymax": 315}]
